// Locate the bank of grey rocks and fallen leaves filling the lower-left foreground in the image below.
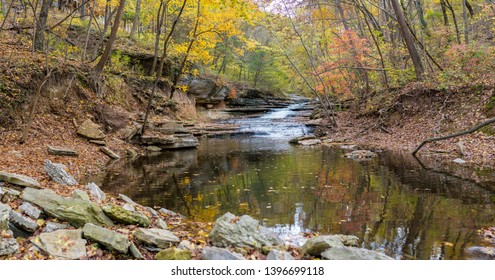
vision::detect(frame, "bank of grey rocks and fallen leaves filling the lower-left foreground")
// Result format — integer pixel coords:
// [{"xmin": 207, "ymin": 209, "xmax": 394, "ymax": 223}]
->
[{"xmin": 0, "ymin": 166, "xmax": 391, "ymax": 260}]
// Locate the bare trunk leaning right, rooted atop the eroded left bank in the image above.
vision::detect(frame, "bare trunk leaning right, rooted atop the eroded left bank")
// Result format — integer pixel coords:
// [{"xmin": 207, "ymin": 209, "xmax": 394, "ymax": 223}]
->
[{"xmin": 92, "ymin": 0, "xmax": 126, "ymax": 96}]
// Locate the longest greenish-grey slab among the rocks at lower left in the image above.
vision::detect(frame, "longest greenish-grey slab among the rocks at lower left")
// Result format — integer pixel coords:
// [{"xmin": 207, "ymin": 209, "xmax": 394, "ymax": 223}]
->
[{"xmin": 22, "ymin": 188, "xmax": 114, "ymax": 227}]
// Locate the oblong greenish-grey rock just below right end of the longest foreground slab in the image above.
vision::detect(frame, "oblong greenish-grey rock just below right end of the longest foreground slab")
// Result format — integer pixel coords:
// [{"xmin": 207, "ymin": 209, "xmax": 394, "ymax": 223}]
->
[{"xmin": 83, "ymin": 223, "xmax": 130, "ymax": 254}]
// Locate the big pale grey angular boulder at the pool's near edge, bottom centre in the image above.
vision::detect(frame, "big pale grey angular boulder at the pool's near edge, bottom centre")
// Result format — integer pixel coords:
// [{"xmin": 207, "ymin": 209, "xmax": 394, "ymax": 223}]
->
[{"xmin": 209, "ymin": 213, "xmax": 283, "ymax": 248}]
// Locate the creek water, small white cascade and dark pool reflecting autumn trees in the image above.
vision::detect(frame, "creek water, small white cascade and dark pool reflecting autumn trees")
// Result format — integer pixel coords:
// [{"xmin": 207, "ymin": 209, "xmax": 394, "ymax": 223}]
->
[{"xmin": 100, "ymin": 105, "xmax": 495, "ymax": 259}]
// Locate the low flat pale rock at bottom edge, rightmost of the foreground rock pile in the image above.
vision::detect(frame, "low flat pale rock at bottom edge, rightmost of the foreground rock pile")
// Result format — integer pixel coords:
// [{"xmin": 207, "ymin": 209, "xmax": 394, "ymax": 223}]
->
[{"xmin": 321, "ymin": 246, "xmax": 393, "ymax": 260}]
